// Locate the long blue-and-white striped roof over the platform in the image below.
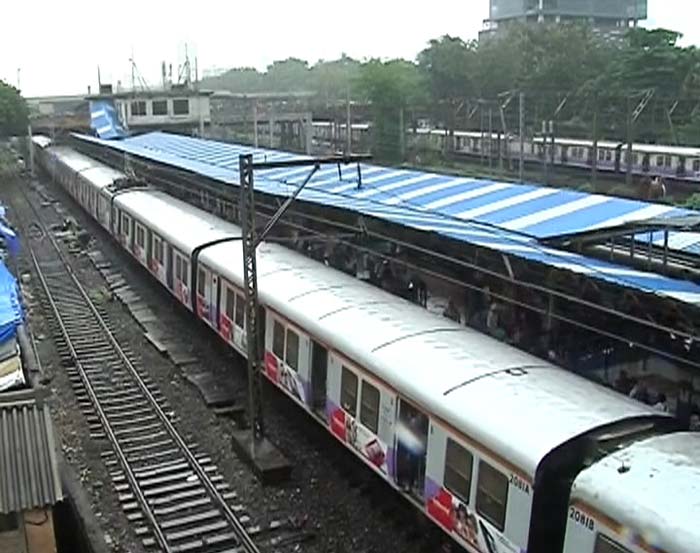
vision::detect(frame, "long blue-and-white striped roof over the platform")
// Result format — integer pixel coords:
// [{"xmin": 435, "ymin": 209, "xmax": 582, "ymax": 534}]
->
[{"xmin": 78, "ymin": 132, "xmax": 700, "ymax": 305}]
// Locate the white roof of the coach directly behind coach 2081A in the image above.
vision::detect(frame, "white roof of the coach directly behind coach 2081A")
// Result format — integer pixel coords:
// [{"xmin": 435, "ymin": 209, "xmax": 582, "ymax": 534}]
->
[{"xmin": 114, "ymin": 190, "xmax": 241, "ymax": 255}]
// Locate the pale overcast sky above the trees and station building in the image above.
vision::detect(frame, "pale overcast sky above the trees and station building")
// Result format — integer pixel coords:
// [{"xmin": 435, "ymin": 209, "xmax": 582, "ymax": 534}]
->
[{"xmin": 0, "ymin": 0, "xmax": 700, "ymax": 96}]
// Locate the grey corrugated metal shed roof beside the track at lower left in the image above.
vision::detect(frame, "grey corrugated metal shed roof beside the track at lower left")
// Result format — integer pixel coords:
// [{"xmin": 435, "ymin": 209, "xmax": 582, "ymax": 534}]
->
[{"xmin": 0, "ymin": 390, "xmax": 63, "ymax": 514}]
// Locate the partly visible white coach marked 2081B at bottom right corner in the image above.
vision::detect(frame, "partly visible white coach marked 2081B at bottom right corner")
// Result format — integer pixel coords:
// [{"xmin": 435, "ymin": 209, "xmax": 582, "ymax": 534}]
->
[{"xmin": 565, "ymin": 433, "xmax": 700, "ymax": 553}]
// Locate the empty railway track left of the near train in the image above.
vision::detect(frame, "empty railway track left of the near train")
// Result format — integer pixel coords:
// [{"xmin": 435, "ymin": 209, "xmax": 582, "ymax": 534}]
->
[{"xmin": 14, "ymin": 184, "xmax": 260, "ymax": 553}]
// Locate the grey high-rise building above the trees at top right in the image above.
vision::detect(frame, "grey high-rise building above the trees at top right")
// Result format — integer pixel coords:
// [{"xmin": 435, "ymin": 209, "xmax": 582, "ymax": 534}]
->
[{"xmin": 480, "ymin": 0, "xmax": 647, "ymax": 38}]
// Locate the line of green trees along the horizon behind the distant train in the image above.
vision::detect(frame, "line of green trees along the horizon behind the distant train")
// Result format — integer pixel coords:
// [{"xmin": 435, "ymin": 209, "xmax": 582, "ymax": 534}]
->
[{"xmin": 203, "ymin": 24, "xmax": 700, "ymax": 159}]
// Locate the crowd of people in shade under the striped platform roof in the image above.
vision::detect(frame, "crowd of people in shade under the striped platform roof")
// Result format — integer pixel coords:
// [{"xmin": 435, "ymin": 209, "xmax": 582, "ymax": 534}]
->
[{"xmin": 288, "ymin": 226, "xmax": 700, "ymax": 430}]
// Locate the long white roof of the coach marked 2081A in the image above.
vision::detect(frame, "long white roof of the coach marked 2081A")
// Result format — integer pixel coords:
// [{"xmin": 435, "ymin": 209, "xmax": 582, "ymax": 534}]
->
[{"xmin": 200, "ymin": 237, "xmax": 657, "ymax": 477}]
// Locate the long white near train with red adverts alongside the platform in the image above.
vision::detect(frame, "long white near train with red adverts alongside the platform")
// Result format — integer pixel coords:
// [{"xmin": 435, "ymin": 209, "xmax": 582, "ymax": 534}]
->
[{"xmin": 35, "ymin": 138, "xmax": 700, "ymax": 553}]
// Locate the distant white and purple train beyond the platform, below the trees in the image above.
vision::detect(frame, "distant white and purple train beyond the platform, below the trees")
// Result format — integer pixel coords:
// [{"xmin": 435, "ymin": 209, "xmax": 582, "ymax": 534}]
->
[{"xmin": 313, "ymin": 121, "xmax": 700, "ymax": 183}]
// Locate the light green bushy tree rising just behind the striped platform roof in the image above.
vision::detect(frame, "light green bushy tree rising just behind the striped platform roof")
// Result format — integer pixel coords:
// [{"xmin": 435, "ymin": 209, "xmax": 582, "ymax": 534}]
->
[{"xmin": 356, "ymin": 59, "xmax": 426, "ymax": 161}]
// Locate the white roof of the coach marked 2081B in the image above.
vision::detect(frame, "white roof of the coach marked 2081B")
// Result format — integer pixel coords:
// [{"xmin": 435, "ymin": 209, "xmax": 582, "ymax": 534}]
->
[{"xmin": 572, "ymin": 432, "xmax": 700, "ymax": 553}]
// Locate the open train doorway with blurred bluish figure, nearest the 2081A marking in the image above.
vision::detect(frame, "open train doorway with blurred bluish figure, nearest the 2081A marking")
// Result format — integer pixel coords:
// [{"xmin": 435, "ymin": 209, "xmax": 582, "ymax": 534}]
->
[{"xmin": 396, "ymin": 399, "xmax": 429, "ymax": 502}]
